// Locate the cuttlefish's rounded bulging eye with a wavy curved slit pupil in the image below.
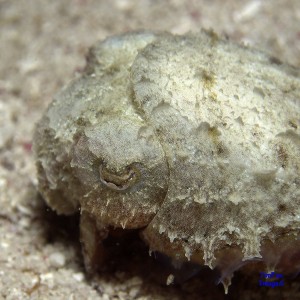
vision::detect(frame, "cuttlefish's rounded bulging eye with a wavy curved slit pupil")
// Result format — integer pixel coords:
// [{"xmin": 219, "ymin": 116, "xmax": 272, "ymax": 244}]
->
[{"xmin": 72, "ymin": 118, "xmax": 168, "ymax": 228}]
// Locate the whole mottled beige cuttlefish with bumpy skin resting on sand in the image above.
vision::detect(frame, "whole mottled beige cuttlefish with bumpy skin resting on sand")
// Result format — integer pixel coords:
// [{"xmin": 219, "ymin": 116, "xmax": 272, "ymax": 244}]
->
[{"xmin": 34, "ymin": 31, "xmax": 300, "ymax": 290}]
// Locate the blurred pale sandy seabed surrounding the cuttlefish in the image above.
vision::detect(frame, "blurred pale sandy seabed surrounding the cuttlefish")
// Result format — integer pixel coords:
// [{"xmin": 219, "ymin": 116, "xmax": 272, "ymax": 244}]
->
[{"xmin": 0, "ymin": 0, "xmax": 300, "ymax": 300}]
